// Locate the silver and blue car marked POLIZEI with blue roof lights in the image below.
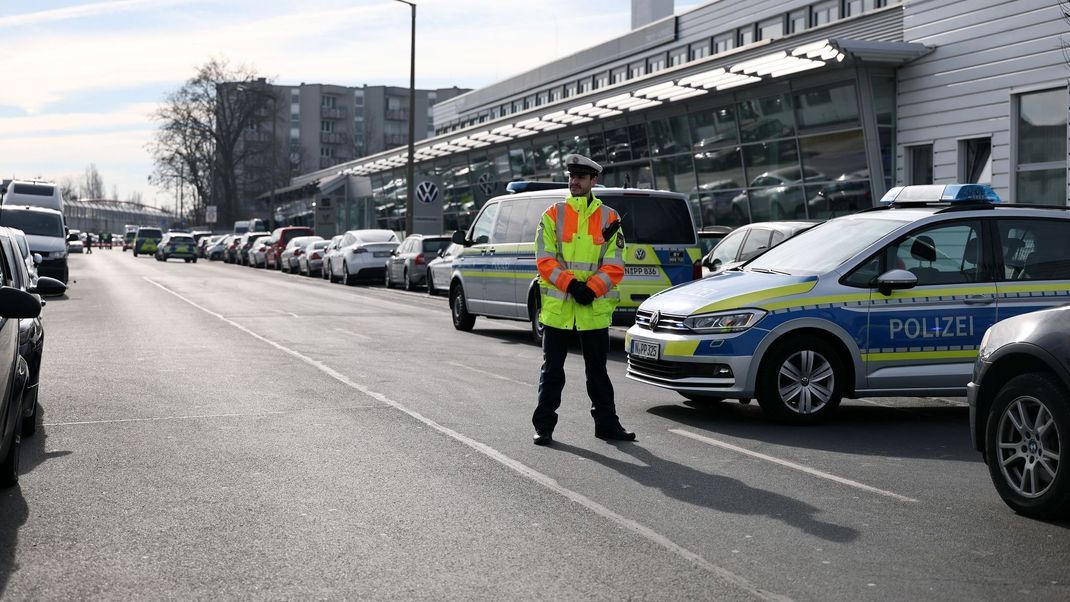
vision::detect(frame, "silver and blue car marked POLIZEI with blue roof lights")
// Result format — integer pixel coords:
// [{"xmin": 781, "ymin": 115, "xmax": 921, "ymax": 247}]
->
[{"xmin": 626, "ymin": 184, "xmax": 1070, "ymax": 423}]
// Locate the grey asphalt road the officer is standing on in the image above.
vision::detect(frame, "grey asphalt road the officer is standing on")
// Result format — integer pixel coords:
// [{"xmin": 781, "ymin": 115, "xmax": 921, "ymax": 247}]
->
[{"xmin": 0, "ymin": 249, "xmax": 1070, "ymax": 600}]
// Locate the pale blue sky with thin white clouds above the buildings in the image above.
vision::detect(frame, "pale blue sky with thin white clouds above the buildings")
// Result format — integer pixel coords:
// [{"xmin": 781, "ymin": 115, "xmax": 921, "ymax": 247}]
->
[{"xmin": 0, "ymin": 0, "xmax": 704, "ymax": 207}]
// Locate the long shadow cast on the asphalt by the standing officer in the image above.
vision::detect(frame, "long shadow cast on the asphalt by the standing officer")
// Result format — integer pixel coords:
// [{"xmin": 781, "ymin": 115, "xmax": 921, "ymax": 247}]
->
[{"xmin": 553, "ymin": 441, "xmax": 858, "ymax": 543}]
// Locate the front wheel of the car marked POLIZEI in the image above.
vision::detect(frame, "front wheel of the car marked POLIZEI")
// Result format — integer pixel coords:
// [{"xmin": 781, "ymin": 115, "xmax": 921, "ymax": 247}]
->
[{"xmin": 758, "ymin": 337, "xmax": 845, "ymax": 425}]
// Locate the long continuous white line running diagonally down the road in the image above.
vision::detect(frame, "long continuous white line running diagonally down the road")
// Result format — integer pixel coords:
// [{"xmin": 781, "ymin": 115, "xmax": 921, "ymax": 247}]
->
[{"xmin": 144, "ymin": 277, "xmax": 791, "ymax": 600}]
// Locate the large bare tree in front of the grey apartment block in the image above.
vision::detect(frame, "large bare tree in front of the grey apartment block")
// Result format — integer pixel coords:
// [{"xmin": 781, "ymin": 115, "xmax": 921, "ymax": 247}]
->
[{"xmin": 150, "ymin": 59, "xmax": 284, "ymax": 227}]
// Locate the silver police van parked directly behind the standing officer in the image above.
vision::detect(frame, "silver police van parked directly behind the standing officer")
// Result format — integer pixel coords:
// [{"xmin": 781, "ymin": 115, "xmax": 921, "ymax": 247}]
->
[{"xmin": 449, "ymin": 188, "xmax": 701, "ymax": 342}]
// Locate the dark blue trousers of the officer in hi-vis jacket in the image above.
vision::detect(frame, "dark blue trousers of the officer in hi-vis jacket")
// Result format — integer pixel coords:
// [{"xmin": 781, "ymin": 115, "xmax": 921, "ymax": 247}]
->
[{"xmin": 532, "ymin": 326, "xmax": 620, "ymax": 434}]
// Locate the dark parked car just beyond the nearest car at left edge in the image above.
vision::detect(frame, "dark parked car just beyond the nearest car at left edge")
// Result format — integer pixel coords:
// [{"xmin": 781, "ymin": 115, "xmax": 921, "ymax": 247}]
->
[{"xmin": 0, "ymin": 228, "xmax": 66, "ymax": 436}]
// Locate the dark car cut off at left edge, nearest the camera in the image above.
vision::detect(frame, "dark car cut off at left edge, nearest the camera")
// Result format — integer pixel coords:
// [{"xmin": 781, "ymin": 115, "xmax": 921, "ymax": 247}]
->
[{"xmin": 0, "ymin": 240, "xmax": 47, "ymax": 487}]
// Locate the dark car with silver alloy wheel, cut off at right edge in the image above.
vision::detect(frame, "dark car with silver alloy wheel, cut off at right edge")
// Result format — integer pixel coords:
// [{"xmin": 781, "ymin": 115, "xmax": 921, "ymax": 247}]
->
[{"xmin": 966, "ymin": 306, "xmax": 1070, "ymax": 519}]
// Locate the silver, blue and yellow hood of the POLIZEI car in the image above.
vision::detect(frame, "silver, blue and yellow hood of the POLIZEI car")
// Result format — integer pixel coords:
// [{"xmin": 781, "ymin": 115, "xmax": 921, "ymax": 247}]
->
[{"xmin": 639, "ymin": 271, "xmax": 817, "ymax": 315}]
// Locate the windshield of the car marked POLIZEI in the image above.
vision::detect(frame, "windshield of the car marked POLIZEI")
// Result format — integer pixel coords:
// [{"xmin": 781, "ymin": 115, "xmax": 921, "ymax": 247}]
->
[{"xmin": 744, "ymin": 218, "xmax": 903, "ymax": 276}]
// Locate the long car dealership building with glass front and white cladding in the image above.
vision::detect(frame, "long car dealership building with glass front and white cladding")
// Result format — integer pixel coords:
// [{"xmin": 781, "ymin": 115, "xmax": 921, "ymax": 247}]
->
[{"xmin": 280, "ymin": 0, "xmax": 1070, "ymax": 233}]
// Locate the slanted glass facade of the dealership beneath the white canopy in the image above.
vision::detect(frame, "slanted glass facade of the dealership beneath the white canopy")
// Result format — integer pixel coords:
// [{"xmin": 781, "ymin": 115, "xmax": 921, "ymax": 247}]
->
[{"xmin": 340, "ymin": 76, "xmax": 898, "ymax": 231}]
